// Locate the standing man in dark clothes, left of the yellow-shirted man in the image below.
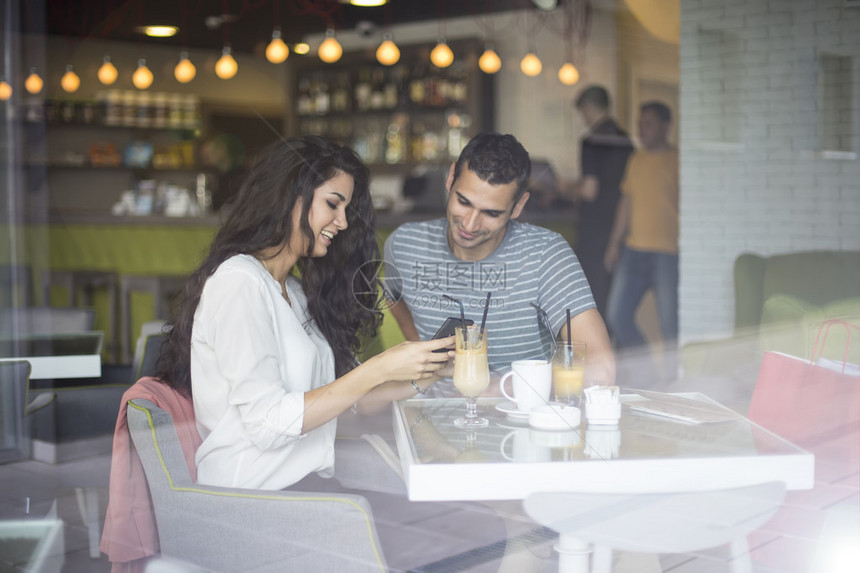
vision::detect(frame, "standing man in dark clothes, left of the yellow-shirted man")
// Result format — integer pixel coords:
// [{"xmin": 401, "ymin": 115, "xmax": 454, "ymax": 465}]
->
[{"xmin": 568, "ymin": 86, "xmax": 633, "ymax": 322}]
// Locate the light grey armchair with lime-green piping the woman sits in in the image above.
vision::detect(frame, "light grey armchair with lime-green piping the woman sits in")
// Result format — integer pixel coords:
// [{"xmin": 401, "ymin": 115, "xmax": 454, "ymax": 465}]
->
[{"xmin": 128, "ymin": 399, "xmax": 386, "ymax": 572}]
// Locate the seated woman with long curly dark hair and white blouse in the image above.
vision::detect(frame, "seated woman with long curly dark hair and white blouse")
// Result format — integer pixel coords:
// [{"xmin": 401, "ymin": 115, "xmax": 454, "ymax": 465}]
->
[{"xmin": 159, "ymin": 137, "xmax": 453, "ymax": 489}]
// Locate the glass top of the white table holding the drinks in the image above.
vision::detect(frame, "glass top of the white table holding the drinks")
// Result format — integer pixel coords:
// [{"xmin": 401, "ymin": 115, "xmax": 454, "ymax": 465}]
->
[{"xmin": 397, "ymin": 394, "xmax": 803, "ymax": 464}]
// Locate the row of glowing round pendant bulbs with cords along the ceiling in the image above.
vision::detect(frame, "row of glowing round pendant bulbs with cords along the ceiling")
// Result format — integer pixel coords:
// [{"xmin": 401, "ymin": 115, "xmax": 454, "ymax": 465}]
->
[{"xmin": 0, "ymin": 0, "xmax": 590, "ymax": 99}]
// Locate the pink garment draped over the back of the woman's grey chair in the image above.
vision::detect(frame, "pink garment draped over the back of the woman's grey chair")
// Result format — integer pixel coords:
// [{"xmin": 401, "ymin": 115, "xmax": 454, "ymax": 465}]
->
[{"xmin": 99, "ymin": 378, "xmax": 201, "ymax": 573}]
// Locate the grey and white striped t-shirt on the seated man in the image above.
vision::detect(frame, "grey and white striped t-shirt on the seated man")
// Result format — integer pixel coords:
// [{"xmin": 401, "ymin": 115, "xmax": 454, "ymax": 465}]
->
[{"xmin": 385, "ymin": 219, "xmax": 594, "ymax": 372}]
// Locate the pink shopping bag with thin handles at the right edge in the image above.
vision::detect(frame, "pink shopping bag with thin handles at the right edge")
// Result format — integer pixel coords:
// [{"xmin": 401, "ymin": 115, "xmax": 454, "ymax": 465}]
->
[{"xmin": 747, "ymin": 319, "xmax": 860, "ymax": 483}]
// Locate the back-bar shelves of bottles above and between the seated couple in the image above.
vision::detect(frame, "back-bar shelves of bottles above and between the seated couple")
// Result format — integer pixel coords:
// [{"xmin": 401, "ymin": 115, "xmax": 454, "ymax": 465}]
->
[{"xmin": 295, "ymin": 40, "xmax": 493, "ymax": 167}]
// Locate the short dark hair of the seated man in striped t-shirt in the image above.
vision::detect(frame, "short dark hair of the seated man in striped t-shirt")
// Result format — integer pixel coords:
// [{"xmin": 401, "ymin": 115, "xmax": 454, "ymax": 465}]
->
[{"xmin": 454, "ymin": 132, "xmax": 532, "ymax": 203}]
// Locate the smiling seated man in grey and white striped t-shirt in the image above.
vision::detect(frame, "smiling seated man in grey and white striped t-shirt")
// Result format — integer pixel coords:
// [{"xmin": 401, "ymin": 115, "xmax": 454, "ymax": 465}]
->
[{"xmin": 385, "ymin": 133, "xmax": 615, "ymax": 389}]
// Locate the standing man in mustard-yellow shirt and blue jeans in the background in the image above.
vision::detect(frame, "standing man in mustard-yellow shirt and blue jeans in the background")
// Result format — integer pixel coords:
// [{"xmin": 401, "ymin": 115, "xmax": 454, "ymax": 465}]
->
[{"xmin": 604, "ymin": 102, "xmax": 679, "ymax": 348}]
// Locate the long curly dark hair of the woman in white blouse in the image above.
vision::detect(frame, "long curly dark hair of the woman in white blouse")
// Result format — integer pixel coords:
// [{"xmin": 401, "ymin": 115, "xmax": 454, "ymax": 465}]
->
[{"xmin": 158, "ymin": 136, "xmax": 381, "ymax": 396}]
